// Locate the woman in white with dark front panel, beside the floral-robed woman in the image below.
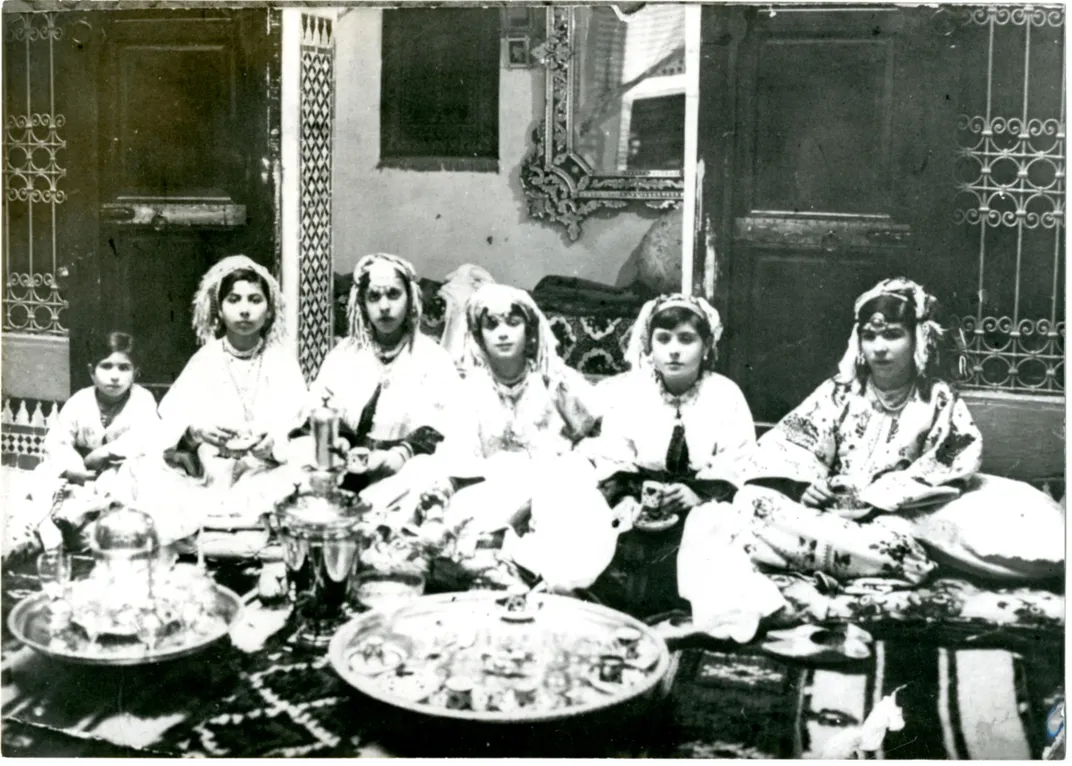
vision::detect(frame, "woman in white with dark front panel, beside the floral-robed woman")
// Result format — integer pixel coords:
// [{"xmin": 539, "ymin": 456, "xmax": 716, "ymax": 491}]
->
[{"xmin": 580, "ymin": 295, "xmax": 756, "ymax": 611}]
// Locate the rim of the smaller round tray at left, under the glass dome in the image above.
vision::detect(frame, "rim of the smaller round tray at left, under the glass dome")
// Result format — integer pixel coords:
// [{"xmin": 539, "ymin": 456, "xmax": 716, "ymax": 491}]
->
[{"xmin": 8, "ymin": 585, "xmax": 242, "ymax": 665}]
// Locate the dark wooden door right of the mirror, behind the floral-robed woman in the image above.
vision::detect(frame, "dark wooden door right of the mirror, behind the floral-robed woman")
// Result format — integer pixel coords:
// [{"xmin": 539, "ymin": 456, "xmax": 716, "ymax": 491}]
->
[{"xmin": 697, "ymin": 5, "xmax": 956, "ymax": 422}]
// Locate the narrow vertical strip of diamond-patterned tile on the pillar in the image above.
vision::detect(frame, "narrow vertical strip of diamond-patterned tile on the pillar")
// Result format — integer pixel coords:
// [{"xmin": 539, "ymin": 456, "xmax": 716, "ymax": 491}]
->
[{"xmin": 298, "ymin": 14, "xmax": 336, "ymax": 379}]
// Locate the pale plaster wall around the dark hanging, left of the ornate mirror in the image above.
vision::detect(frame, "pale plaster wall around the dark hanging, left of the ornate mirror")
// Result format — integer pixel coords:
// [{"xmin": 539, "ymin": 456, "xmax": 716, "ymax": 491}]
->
[{"xmin": 332, "ymin": 7, "xmax": 657, "ymax": 289}]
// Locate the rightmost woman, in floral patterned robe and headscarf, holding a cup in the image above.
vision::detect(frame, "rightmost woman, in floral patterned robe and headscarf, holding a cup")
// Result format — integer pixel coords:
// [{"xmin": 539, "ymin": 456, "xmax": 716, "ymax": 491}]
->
[{"xmin": 735, "ymin": 279, "xmax": 982, "ymax": 583}]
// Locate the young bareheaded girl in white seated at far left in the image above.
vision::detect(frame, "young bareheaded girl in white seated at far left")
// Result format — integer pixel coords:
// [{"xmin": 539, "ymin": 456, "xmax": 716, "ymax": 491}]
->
[{"xmin": 4, "ymin": 332, "xmax": 159, "ymax": 554}]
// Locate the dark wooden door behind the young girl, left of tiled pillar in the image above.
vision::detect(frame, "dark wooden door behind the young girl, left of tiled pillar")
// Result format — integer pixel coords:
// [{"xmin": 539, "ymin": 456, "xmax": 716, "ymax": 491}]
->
[{"xmin": 71, "ymin": 9, "xmax": 278, "ymax": 395}]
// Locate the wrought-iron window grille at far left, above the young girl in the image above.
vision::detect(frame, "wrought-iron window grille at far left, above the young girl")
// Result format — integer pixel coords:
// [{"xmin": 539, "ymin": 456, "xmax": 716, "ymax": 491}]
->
[{"xmin": 3, "ymin": 13, "xmax": 68, "ymax": 335}]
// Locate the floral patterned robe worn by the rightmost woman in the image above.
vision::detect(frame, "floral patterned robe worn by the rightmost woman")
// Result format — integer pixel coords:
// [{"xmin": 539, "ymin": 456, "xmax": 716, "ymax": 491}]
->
[{"xmin": 734, "ymin": 379, "xmax": 982, "ymax": 583}]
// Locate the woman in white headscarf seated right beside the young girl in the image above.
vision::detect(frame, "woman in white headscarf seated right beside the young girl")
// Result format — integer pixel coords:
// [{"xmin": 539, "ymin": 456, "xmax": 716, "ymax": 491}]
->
[{"xmin": 127, "ymin": 255, "xmax": 308, "ymax": 542}]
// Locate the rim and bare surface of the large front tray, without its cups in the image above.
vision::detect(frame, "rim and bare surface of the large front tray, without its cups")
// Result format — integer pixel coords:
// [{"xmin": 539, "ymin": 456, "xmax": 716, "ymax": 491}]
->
[{"xmin": 328, "ymin": 591, "xmax": 670, "ymax": 723}]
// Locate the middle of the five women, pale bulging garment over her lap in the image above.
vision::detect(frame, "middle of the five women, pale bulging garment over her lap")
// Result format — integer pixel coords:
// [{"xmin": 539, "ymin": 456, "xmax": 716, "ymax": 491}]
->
[{"xmin": 442, "ymin": 284, "xmax": 616, "ymax": 588}]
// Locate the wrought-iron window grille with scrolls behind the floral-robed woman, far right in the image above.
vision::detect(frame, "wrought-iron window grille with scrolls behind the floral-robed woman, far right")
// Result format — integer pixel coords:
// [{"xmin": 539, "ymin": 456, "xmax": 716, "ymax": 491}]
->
[{"xmin": 954, "ymin": 5, "xmax": 1066, "ymax": 394}]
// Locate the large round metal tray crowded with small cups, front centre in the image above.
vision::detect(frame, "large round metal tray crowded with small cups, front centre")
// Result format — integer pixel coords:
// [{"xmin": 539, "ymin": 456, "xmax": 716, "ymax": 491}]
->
[{"xmin": 328, "ymin": 591, "xmax": 670, "ymax": 723}]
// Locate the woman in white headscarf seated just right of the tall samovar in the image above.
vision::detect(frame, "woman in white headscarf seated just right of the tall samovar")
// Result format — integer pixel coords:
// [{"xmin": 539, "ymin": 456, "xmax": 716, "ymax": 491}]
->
[{"xmin": 310, "ymin": 253, "xmax": 463, "ymax": 516}]
